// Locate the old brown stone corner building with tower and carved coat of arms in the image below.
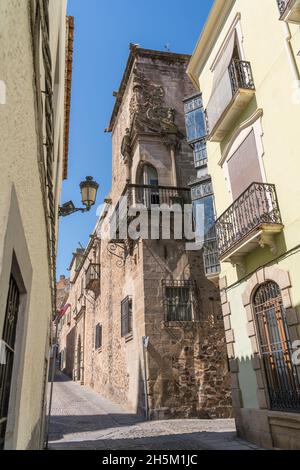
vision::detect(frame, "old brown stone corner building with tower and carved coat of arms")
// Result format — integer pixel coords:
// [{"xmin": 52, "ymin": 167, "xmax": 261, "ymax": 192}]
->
[{"xmin": 60, "ymin": 46, "xmax": 232, "ymax": 419}]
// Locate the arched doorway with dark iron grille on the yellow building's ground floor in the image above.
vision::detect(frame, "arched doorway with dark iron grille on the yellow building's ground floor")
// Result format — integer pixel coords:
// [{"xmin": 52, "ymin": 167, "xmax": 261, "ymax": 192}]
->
[{"xmin": 254, "ymin": 282, "xmax": 300, "ymax": 412}]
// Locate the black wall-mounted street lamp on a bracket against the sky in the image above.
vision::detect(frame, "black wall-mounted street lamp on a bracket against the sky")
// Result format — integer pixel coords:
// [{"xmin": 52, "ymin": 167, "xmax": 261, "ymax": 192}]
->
[{"xmin": 59, "ymin": 176, "xmax": 99, "ymax": 217}]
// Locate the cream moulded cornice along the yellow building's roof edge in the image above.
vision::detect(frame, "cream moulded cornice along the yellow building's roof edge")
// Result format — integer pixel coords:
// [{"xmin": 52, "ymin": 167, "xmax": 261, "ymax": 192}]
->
[{"xmin": 187, "ymin": 0, "xmax": 235, "ymax": 90}]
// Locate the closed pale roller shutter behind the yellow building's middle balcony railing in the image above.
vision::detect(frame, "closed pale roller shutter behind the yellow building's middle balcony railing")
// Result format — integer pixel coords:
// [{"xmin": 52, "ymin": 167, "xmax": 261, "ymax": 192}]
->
[{"xmin": 228, "ymin": 130, "xmax": 263, "ymax": 200}]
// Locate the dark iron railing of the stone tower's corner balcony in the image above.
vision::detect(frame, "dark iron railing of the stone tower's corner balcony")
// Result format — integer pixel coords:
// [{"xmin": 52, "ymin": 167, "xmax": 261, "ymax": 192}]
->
[{"xmin": 123, "ymin": 184, "xmax": 191, "ymax": 209}]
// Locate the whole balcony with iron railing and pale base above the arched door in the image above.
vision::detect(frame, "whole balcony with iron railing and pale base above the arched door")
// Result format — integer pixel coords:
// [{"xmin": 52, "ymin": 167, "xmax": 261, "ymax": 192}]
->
[{"xmin": 216, "ymin": 183, "xmax": 283, "ymax": 266}]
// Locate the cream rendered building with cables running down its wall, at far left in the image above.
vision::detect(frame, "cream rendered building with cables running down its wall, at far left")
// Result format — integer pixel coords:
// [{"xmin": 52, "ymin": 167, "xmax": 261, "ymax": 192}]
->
[{"xmin": 0, "ymin": 0, "xmax": 73, "ymax": 450}]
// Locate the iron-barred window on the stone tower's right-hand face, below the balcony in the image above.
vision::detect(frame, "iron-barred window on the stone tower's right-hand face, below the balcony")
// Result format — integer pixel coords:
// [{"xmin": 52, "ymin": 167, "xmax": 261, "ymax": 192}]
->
[{"xmin": 163, "ymin": 280, "xmax": 196, "ymax": 322}]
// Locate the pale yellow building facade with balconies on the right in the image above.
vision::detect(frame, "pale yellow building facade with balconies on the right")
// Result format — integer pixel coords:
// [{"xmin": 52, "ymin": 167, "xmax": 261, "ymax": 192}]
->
[{"xmin": 188, "ymin": 0, "xmax": 300, "ymax": 449}]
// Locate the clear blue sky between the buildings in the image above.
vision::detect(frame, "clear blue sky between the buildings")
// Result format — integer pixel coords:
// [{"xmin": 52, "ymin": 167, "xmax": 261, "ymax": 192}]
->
[{"xmin": 57, "ymin": 0, "xmax": 213, "ymax": 276}]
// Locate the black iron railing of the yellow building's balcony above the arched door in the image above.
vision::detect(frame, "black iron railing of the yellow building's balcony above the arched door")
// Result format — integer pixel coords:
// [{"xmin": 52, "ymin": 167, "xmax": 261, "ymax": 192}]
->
[{"xmin": 216, "ymin": 183, "xmax": 282, "ymax": 257}]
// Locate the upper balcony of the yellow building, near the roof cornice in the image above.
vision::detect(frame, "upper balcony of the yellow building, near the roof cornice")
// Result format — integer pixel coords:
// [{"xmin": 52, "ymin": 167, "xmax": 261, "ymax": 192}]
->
[{"xmin": 206, "ymin": 59, "xmax": 255, "ymax": 142}]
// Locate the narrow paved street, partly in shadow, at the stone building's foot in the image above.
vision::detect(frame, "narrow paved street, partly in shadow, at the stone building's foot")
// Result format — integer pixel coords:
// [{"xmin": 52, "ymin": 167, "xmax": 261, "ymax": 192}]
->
[{"xmin": 49, "ymin": 375, "xmax": 257, "ymax": 450}]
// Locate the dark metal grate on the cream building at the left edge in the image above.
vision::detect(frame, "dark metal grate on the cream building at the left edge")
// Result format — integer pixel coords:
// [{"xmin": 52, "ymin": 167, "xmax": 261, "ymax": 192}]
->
[{"xmin": 0, "ymin": 276, "xmax": 20, "ymax": 449}]
